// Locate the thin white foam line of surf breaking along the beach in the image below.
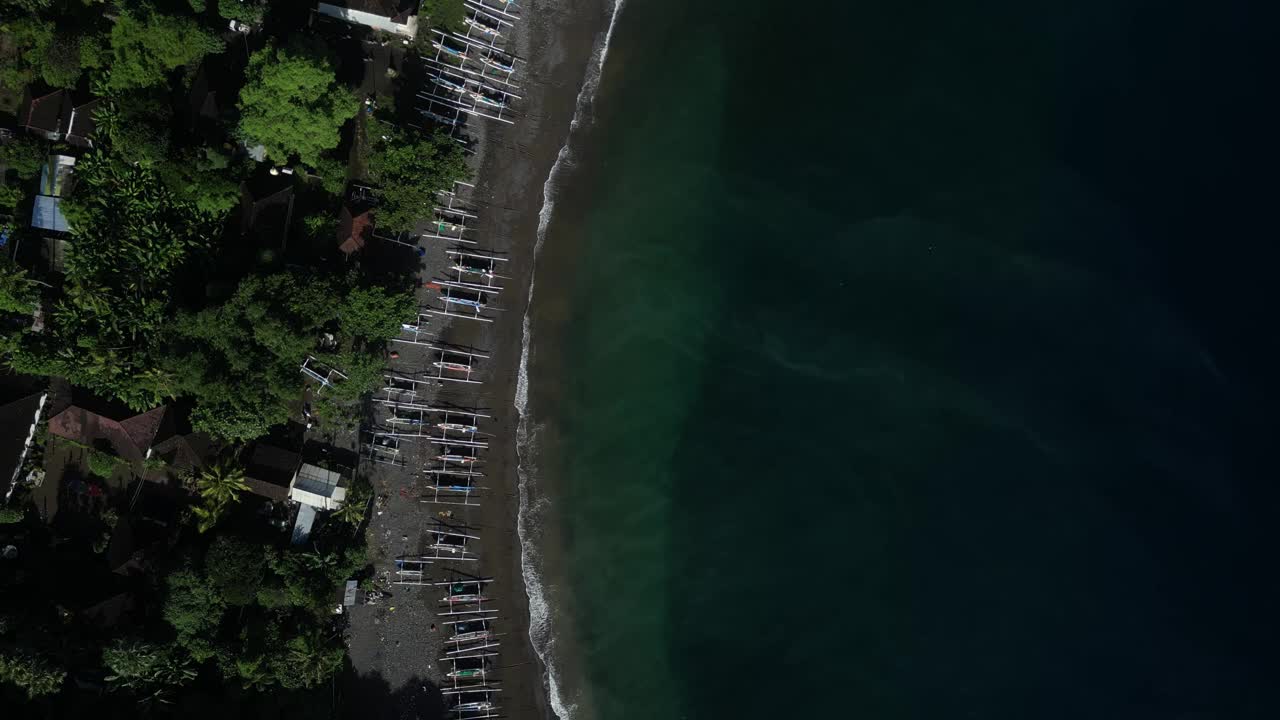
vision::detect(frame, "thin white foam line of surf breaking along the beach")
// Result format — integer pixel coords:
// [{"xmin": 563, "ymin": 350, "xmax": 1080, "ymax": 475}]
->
[{"xmin": 515, "ymin": 0, "xmax": 625, "ymax": 720}]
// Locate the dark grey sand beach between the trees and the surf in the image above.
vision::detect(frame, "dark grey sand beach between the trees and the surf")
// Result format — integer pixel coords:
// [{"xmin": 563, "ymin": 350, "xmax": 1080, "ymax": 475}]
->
[{"xmin": 337, "ymin": 0, "xmax": 611, "ymax": 720}]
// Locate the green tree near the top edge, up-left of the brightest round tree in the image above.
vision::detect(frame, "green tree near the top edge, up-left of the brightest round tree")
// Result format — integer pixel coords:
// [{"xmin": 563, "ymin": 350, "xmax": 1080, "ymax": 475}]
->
[{"xmin": 106, "ymin": 5, "xmax": 223, "ymax": 90}]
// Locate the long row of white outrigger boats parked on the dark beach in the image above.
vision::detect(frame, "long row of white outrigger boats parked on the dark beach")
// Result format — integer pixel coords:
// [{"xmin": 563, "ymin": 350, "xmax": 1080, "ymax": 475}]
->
[{"xmin": 389, "ymin": 0, "xmax": 521, "ymax": 720}]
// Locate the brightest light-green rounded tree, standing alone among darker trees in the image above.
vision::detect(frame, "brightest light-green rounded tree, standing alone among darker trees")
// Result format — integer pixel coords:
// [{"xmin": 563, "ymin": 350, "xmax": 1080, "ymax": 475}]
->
[{"xmin": 239, "ymin": 42, "xmax": 360, "ymax": 167}]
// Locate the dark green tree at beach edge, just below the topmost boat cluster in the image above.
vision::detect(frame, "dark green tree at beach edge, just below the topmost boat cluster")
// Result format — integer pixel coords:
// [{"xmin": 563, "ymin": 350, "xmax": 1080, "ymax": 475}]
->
[{"xmin": 369, "ymin": 131, "xmax": 467, "ymax": 231}]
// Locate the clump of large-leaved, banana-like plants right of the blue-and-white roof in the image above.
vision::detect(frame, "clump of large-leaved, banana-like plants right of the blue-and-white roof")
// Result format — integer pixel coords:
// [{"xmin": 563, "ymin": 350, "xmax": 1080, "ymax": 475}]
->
[{"xmin": 9, "ymin": 152, "xmax": 218, "ymax": 410}]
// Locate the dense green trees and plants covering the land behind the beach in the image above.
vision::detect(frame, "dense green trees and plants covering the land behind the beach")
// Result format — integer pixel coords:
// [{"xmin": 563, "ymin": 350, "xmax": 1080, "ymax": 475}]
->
[{"xmin": 0, "ymin": 0, "xmax": 467, "ymax": 716}]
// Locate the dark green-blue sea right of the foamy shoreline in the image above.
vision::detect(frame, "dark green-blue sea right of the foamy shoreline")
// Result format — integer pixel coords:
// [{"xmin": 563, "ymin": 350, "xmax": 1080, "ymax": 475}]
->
[{"xmin": 521, "ymin": 0, "xmax": 1280, "ymax": 720}]
